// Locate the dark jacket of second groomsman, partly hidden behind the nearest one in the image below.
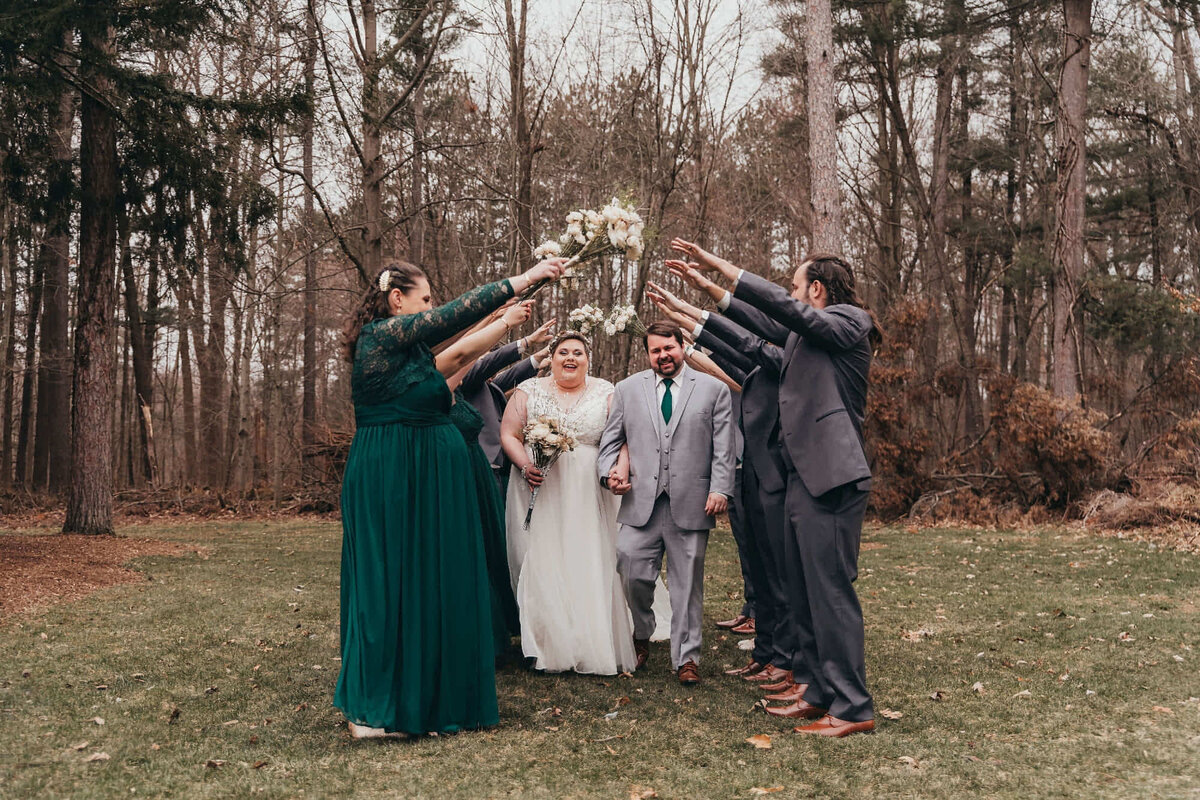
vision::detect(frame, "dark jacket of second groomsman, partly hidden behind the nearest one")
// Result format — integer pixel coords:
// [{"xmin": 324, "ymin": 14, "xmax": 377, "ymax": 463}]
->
[{"xmin": 696, "ymin": 306, "xmax": 786, "ymax": 492}]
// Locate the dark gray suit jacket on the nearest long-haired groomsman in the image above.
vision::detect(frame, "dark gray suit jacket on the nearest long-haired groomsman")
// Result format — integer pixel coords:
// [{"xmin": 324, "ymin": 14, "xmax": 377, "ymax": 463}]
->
[{"xmin": 734, "ymin": 272, "xmax": 872, "ymax": 497}]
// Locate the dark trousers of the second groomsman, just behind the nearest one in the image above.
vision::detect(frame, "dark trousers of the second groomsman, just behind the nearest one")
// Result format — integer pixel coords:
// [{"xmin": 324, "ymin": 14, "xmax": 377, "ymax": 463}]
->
[{"xmin": 742, "ymin": 465, "xmax": 796, "ymax": 669}]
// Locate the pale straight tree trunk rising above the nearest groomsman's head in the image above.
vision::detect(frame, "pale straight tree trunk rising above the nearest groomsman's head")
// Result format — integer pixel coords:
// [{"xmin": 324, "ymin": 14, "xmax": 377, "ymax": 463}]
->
[{"xmin": 804, "ymin": 0, "xmax": 842, "ymax": 253}]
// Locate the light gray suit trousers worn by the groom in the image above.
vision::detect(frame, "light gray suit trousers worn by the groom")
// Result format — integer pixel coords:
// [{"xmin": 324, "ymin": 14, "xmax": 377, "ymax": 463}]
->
[{"xmin": 617, "ymin": 492, "xmax": 708, "ymax": 669}]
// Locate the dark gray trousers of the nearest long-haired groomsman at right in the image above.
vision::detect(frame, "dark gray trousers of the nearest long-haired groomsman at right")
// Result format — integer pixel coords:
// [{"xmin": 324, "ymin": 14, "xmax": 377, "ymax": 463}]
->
[{"xmin": 784, "ymin": 468, "xmax": 875, "ymax": 722}]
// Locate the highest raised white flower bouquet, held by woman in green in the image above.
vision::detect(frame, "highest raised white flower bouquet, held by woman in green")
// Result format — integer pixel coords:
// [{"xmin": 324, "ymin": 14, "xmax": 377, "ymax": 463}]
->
[{"xmin": 526, "ymin": 198, "xmax": 646, "ymax": 296}]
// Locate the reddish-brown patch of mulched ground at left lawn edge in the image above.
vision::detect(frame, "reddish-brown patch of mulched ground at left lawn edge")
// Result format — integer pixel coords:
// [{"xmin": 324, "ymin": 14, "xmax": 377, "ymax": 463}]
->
[{"xmin": 0, "ymin": 534, "xmax": 198, "ymax": 621}]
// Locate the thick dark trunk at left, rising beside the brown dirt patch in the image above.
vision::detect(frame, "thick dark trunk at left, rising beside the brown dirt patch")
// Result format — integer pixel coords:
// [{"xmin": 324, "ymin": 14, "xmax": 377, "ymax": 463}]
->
[{"xmin": 62, "ymin": 20, "xmax": 119, "ymax": 534}]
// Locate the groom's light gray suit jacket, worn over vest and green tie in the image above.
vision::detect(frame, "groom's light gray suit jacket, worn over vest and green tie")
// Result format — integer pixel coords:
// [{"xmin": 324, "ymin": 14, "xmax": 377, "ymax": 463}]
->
[{"xmin": 596, "ymin": 368, "xmax": 736, "ymax": 530}]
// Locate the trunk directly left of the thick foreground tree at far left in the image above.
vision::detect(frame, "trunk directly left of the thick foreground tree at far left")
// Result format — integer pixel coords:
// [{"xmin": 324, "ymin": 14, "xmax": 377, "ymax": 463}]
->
[{"xmin": 34, "ymin": 67, "xmax": 76, "ymax": 493}]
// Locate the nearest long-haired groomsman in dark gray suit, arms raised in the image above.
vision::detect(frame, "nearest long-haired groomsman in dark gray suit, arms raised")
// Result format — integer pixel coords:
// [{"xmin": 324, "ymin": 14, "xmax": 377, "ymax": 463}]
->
[{"xmin": 672, "ymin": 239, "xmax": 880, "ymax": 736}]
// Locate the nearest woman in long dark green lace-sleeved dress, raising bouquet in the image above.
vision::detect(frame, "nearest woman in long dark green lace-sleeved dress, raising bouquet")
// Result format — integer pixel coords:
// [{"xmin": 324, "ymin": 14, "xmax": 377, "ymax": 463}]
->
[{"xmin": 334, "ymin": 259, "xmax": 562, "ymax": 738}]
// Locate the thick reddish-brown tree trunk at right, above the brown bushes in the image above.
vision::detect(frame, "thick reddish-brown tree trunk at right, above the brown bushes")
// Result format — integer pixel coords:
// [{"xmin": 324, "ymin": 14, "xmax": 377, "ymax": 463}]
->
[{"xmin": 1050, "ymin": 0, "xmax": 1092, "ymax": 398}]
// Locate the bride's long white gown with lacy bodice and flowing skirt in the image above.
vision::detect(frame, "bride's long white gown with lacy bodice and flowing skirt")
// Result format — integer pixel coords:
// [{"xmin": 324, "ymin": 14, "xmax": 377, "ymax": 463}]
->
[{"xmin": 506, "ymin": 378, "xmax": 671, "ymax": 675}]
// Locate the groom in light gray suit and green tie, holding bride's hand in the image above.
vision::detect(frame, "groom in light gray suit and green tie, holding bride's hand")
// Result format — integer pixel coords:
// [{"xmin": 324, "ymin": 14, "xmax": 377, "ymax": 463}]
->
[{"xmin": 596, "ymin": 323, "xmax": 736, "ymax": 685}]
